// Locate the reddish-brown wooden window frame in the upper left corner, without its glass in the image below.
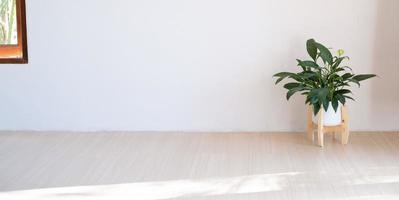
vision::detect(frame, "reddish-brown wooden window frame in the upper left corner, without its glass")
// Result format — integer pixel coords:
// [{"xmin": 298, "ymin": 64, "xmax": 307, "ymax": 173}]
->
[{"xmin": 0, "ymin": 0, "xmax": 28, "ymax": 64}]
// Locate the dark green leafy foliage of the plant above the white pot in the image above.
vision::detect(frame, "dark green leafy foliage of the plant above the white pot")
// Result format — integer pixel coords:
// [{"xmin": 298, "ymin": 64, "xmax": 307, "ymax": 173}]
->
[{"xmin": 273, "ymin": 39, "xmax": 376, "ymax": 114}]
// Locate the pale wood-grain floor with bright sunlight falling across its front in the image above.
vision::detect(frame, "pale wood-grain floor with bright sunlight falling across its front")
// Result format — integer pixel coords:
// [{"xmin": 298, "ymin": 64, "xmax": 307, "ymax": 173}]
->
[{"xmin": 0, "ymin": 132, "xmax": 399, "ymax": 200}]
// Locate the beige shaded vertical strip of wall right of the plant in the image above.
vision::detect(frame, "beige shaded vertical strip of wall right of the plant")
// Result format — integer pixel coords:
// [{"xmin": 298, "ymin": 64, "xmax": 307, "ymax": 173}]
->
[{"xmin": 370, "ymin": 0, "xmax": 399, "ymax": 131}]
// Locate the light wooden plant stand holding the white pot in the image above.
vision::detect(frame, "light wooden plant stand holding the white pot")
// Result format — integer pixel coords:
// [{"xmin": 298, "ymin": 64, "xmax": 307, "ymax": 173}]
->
[{"xmin": 308, "ymin": 106, "xmax": 349, "ymax": 147}]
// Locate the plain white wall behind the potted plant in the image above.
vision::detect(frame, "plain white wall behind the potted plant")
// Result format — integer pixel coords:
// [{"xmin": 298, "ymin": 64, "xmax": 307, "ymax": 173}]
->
[{"xmin": 0, "ymin": 0, "xmax": 399, "ymax": 131}]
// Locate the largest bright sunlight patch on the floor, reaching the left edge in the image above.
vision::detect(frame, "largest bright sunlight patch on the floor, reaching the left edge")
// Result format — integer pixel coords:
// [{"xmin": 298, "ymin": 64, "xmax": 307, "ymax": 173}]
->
[{"xmin": 0, "ymin": 172, "xmax": 300, "ymax": 200}]
